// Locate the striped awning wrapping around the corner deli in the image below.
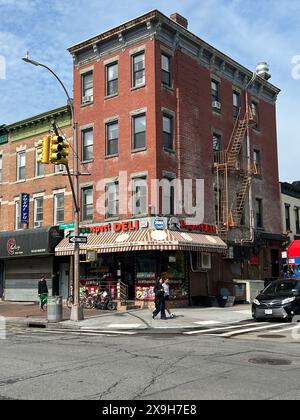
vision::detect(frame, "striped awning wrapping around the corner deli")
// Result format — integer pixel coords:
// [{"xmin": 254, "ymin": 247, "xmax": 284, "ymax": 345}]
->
[{"xmin": 55, "ymin": 229, "xmax": 227, "ymax": 256}]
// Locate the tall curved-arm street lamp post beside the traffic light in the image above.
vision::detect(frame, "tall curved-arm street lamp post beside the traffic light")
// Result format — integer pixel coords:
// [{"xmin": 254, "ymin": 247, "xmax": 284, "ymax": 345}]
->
[{"xmin": 22, "ymin": 54, "xmax": 83, "ymax": 321}]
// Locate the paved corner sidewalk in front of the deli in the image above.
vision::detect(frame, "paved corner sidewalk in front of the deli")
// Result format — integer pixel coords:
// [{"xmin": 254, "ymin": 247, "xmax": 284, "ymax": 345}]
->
[{"xmin": 0, "ymin": 302, "xmax": 252, "ymax": 332}]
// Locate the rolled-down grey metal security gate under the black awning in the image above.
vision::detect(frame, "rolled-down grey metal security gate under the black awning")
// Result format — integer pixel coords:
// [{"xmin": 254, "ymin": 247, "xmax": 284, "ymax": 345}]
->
[{"xmin": 4, "ymin": 257, "xmax": 52, "ymax": 302}]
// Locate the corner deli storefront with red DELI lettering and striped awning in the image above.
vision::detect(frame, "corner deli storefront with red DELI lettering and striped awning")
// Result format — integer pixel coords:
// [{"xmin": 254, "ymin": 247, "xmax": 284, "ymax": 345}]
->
[{"xmin": 55, "ymin": 218, "xmax": 227, "ymax": 306}]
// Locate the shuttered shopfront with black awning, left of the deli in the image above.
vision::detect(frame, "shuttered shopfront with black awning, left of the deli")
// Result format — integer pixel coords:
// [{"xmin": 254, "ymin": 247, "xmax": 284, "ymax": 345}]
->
[{"xmin": 0, "ymin": 227, "xmax": 63, "ymax": 302}]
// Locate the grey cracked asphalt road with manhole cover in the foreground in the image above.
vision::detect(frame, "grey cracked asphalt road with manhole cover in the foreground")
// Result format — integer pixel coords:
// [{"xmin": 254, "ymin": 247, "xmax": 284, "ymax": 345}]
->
[{"xmin": 0, "ymin": 324, "xmax": 300, "ymax": 400}]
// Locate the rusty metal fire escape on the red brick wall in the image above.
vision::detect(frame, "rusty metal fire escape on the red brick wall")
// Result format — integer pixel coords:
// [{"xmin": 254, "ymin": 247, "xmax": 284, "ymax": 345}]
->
[{"xmin": 214, "ymin": 106, "xmax": 255, "ymax": 239}]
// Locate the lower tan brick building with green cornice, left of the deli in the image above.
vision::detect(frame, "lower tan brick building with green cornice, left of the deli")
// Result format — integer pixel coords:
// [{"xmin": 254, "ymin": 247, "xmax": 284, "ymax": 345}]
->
[{"xmin": 0, "ymin": 107, "xmax": 73, "ymax": 301}]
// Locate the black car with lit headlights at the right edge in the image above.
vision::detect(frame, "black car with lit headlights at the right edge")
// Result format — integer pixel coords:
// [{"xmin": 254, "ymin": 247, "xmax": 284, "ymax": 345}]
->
[{"xmin": 252, "ymin": 279, "xmax": 300, "ymax": 321}]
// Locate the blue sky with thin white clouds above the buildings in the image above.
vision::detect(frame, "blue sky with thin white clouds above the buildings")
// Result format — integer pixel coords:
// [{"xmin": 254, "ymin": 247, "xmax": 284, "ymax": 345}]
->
[{"xmin": 0, "ymin": 0, "xmax": 300, "ymax": 182}]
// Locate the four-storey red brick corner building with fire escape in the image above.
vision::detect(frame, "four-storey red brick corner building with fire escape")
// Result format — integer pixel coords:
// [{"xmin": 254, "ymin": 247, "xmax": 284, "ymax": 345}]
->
[{"xmin": 57, "ymin": 10, "xmax": 284, "ymax": 301}]
